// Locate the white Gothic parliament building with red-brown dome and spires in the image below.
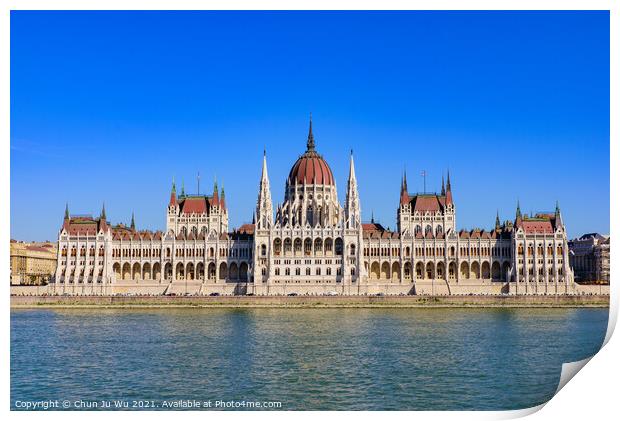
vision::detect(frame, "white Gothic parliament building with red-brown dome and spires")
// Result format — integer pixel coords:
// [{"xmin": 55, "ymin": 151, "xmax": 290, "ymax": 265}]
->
[{"xmin": 50, "ymin": 120, "xmax": 576, "ymax": 295}]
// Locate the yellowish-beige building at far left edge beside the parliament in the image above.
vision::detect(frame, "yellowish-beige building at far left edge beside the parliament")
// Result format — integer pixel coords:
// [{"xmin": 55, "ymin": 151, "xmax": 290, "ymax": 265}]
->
[{"xmin": 11, "ymin": 240, "xmax": 57, "ymax": 285}]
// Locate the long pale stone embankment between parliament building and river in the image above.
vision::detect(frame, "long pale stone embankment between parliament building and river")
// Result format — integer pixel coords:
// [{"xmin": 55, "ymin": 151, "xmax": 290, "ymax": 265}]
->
[{"xmin": 11, "ymin": 295, "xmax": 609, "ymax": 308}]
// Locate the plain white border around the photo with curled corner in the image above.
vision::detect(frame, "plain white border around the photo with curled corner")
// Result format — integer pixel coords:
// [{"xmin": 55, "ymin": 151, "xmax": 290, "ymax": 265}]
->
[{"xmin": 0, "ymin": 0, "xmax": 620, "ymax": 421}]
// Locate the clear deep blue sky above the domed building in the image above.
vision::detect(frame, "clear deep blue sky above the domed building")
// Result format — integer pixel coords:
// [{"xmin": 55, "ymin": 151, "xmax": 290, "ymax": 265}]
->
[{"xmin": 11, "ymin": 11, "xmax": 609, "ymax": 240}]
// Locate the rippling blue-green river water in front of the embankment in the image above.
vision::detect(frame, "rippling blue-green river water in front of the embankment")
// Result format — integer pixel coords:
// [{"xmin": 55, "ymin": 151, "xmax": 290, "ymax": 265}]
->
[{"xmin": 11, "ymin": 309, "xmax": 608, "ymax": 410}]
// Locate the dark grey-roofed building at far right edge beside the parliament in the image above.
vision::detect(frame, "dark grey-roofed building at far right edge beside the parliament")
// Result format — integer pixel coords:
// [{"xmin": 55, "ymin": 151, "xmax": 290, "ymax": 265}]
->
[{"xmin": 568, "ymin": 232, "xmax": 610, "ymax": 283}]
